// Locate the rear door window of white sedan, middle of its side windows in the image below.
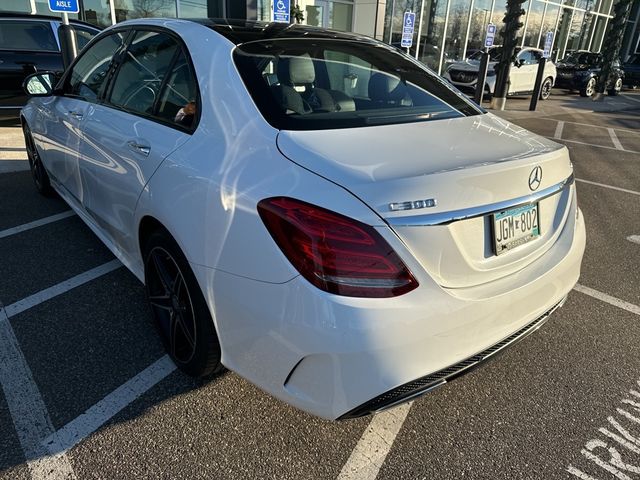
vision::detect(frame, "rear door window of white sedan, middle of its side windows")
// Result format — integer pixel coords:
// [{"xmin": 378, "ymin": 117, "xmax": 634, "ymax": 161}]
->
[{"xmin": 109, "ymin": 31, "xmax": 179, "ymax": 115}]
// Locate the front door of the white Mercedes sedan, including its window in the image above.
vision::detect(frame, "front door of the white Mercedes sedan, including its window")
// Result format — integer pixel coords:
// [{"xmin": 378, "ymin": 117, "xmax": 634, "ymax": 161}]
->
[{"xmin": 42, "ymin": 32, "xmax": 126, "ymax": 203}]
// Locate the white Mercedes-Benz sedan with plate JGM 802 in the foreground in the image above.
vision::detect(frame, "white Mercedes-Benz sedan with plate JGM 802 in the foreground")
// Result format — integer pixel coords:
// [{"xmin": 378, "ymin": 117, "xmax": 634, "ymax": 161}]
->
[{"xmin": 21, "ymin": 19, "xmax": 585, "ymax": 419}]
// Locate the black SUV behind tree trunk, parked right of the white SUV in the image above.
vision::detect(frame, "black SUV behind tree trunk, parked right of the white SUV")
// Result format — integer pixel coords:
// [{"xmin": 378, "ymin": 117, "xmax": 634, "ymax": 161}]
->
[{"xmin": 555, "ymin": 50, "xmax": 624, "ymax": 97}]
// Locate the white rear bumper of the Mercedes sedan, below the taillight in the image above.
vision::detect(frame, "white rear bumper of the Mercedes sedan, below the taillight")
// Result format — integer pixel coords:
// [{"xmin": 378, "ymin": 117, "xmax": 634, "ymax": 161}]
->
[{"xmin": 193, "ymin": 202, "xmax": 585, "ymax": 420}]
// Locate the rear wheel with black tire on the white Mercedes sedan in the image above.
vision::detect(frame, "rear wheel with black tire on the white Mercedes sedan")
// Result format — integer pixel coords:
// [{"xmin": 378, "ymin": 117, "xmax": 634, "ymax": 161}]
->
[{"xmin": 144, "ymin": 230, "xmax": 224, "ymax": 377}]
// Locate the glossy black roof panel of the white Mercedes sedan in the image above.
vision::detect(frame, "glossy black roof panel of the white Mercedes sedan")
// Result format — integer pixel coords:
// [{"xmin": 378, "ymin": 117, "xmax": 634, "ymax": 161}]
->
[{"xmin": 189, "ymin": 18, "xmax": 378, "ymax": 45}]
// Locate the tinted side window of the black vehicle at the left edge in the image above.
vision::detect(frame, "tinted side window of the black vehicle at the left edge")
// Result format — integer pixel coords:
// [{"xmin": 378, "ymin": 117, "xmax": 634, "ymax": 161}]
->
[{"xmin": 0, "ymin": 20, "xmax": 58, "ymax": 52}]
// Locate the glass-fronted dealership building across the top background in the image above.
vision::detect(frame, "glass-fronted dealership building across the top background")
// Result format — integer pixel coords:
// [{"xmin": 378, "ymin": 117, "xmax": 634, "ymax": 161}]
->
[{"xmin": 0, "ymin": 0, "xmax": 640, "ymax": 71}]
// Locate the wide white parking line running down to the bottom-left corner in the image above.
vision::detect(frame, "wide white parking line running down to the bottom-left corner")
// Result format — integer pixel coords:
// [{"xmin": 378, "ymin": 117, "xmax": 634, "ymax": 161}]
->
[{"xmin": 0, "ymin": 308, "xmax": 76, "ymax": 480}]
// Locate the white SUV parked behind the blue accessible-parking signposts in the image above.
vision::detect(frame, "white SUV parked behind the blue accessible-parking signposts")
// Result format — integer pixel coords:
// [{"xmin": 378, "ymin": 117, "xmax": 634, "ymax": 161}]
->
[{"xmin": 443, "ymin": 46, "xmax": 556, "ymax": 100}]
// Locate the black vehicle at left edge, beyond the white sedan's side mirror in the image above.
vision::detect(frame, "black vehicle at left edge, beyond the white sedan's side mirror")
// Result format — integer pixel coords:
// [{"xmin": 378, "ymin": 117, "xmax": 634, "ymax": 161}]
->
[{"xmin": 0, "ymin": 13, "xmax": 100, "ymax": 118}]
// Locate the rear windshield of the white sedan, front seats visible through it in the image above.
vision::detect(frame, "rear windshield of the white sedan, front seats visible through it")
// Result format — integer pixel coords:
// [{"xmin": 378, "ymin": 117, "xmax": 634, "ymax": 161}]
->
[{"xmin": 234, "ymin": 39, "xmax": 483, "ymax": 130}]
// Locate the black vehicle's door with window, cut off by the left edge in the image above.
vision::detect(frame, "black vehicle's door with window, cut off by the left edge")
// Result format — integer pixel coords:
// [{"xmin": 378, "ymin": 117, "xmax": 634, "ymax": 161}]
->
[{"xmin": 0, "ymin": 18, "xmax": 62, "ymax": 109}]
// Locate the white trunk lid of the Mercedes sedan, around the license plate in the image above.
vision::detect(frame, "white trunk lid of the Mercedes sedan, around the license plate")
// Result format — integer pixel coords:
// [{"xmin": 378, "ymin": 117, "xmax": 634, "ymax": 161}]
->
[{"xmin": 278, "ymin": 114, "xmax": 572, "ymax": 288}]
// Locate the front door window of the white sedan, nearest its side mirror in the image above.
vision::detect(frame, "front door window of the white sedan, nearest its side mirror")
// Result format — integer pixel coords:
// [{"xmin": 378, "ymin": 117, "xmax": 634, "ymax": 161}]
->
[{"xmin": 64, "ymin": 32, "xmax": 126, "ymax": 102}]
